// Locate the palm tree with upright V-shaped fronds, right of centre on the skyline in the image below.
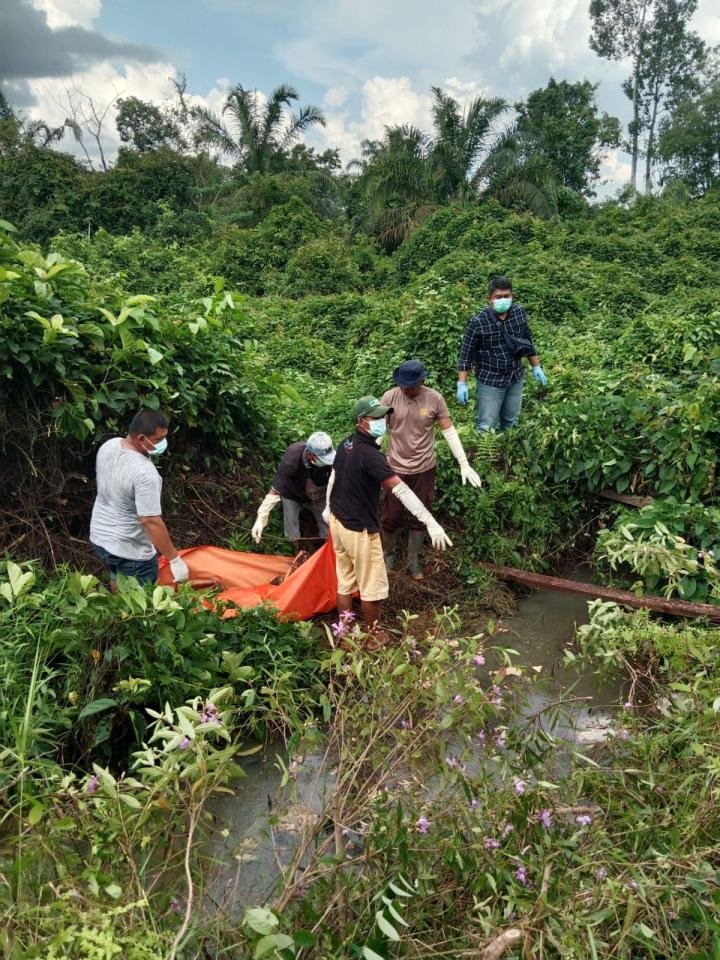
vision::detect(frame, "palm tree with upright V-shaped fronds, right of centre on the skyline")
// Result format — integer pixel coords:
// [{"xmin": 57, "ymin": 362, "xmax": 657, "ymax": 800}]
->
[{"xmin": 430, "ymin": 87, "xmax": 507, "ymax": 203}]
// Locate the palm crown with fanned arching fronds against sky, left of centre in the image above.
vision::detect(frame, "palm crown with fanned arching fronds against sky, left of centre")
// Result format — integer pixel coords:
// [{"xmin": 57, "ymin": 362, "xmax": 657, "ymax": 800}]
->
[{"xmin": 194, "ymin": 83, "xmax": 325, "ymax": 173}]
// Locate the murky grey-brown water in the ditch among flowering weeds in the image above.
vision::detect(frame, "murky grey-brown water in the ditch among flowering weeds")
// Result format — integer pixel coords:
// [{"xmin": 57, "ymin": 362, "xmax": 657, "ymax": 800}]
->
[{"xmin": 207, "ymin": 570, "xmax": 622, "ymax": 916}]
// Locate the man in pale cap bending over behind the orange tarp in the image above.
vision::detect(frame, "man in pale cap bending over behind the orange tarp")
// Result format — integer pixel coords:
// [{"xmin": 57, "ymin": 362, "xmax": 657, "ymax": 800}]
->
[{"xmin": 252, "ymin": 430, "xmax": 335, "ymax": 552}]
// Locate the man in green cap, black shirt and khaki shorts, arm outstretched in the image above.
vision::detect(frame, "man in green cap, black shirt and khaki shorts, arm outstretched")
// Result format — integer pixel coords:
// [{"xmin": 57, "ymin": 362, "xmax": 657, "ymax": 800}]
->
[{"xmin": 326, "ymin": 397, "xmax": 452, "ymax": 630}]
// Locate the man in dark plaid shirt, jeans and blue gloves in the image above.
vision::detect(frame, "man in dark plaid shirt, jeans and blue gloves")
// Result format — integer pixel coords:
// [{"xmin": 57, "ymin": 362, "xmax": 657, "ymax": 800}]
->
[{"xmin": 457, "ymin": 277, "xmax": 547, "ymax": 431}]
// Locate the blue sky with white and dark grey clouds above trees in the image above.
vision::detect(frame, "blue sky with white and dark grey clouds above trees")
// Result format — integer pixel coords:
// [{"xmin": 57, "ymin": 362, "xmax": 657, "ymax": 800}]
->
[{"xmin": 0, "ymin": 0, "xmax": 720, "ymax": 195}]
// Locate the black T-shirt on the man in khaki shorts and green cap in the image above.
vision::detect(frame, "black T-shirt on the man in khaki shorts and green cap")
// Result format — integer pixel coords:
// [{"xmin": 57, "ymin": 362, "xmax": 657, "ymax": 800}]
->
[{"xmin": 330, "ymin": 430, "xmax": 395, "ymax": 533}]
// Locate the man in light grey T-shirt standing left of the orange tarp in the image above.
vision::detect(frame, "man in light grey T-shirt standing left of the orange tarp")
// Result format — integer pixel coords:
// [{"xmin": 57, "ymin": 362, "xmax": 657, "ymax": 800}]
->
[{"xmin": 90, "ymin": 410, "xmax": 189, "ymax": 592}]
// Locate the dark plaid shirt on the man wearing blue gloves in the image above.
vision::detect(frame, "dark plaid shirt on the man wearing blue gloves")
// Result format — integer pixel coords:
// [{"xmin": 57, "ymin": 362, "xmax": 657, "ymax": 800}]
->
[{"xmin": 458, "ymin": 304, "xmax": 532, "ymax": 387}]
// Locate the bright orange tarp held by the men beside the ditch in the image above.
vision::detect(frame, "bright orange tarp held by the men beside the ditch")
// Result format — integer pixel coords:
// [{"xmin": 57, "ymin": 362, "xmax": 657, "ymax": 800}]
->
[{"xmin": 158, "ymin": 540, "xmax": 337, "ymax": 620}]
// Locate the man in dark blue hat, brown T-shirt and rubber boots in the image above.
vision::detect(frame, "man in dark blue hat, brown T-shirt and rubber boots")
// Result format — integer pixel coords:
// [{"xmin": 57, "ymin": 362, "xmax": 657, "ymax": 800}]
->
[{"xmin": 382, "ymin": 360, "xmax": 480, "ymax": 580}]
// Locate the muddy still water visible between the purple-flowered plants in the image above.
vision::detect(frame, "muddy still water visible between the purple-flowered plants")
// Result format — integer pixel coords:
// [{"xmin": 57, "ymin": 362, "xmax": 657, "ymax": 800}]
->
[{"xmin": 208, "ymin": 571, "xmax": 621, "ymax": 914}]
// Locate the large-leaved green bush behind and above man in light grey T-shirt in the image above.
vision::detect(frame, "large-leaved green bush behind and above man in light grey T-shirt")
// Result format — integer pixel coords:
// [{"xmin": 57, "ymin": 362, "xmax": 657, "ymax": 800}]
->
[{"xmin": 0, "ymin": 225, "xmax": 272, "ymax": 451}]
